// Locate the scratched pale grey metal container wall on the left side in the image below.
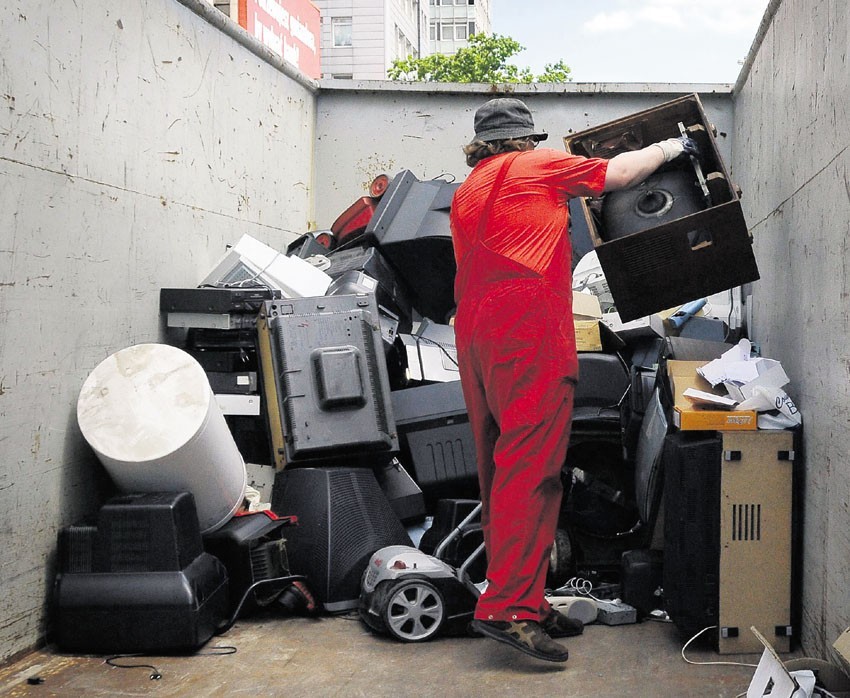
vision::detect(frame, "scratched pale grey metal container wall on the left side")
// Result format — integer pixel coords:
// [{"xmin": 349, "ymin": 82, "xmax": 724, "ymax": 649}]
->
[{"xmin": 0, "ymin": 0, "xmax": 315, "ymax": 657}]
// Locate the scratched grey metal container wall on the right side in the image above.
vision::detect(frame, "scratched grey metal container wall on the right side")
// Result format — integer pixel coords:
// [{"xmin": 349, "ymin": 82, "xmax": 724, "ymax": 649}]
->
[{"xmin": 733, "ymin": 0, "xmax": 850, "ymax": 655}]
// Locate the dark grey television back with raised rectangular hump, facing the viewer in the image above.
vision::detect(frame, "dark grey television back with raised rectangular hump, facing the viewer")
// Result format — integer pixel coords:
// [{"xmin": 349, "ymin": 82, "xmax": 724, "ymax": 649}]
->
[{"xmin": 258, "ymin": 294, "xmax": 398, "ymax": 467}]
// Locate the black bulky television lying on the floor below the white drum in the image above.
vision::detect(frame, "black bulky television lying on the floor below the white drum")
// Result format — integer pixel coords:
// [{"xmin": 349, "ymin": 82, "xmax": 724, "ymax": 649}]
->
[{"xmin": 53, "ymin": 492, "xmax": 228, "ymax": 653}]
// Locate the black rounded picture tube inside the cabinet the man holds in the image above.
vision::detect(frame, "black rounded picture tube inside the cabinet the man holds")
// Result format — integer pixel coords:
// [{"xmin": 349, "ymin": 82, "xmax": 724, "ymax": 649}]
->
[{"xmin": 602, "ymin": 170, "xmax": 705, "ymax": 244}]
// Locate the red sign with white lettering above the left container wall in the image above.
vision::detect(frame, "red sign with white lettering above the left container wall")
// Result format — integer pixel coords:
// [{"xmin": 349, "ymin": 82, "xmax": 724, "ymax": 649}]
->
[{"xmin": 239, "ymin": 0, "xmax": 322, "ymax": 80}]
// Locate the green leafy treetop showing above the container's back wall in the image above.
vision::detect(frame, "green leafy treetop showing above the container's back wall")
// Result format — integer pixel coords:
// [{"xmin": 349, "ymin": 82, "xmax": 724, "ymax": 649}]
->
[{"xmin": 387, "ymin": 34, "xmax": 572, "ymax": 83}]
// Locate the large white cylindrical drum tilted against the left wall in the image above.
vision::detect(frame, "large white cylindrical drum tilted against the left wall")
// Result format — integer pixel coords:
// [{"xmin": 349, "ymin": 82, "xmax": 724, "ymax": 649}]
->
[{"xmin": 77, "ymin": 344, "xmax": 247, "ymax": 533}]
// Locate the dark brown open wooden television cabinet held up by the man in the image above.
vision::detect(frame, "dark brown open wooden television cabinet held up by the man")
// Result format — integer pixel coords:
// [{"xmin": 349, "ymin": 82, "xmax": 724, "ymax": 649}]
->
[{"xmin": 564, "ymin": 94, "xmax": 759, "ymax": 322}]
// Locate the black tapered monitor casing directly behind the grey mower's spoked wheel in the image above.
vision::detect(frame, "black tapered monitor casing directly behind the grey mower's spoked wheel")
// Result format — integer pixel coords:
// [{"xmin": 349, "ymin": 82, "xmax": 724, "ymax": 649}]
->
[{"xmin": 272, "ymin": 467, "xmax": 413, "ymax": 613}]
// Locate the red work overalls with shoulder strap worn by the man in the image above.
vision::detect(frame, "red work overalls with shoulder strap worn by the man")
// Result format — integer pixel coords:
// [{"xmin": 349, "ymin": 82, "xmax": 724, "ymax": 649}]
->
[{"xmin": 455, "ymin": 155, "xmax": 578, "ymax": 620}]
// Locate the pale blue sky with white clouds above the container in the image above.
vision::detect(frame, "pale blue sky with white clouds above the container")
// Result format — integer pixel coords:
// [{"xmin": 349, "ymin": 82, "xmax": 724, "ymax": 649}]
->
[{"xmin": 491, "ymin": 0, "xmax": 769, "ymax": 83}]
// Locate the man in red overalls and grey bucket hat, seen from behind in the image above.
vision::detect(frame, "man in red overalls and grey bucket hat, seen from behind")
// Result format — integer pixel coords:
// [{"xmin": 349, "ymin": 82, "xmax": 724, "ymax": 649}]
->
[{"xmin": 451, "ymin": 98, "xmax": 692, "ymax": 662}]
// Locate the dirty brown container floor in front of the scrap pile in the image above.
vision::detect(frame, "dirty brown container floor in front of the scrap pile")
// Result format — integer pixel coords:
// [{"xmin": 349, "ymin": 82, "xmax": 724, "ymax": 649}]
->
[{"xmin": 0, "ymin": 614, "xmax": 776, "ymax": 698}]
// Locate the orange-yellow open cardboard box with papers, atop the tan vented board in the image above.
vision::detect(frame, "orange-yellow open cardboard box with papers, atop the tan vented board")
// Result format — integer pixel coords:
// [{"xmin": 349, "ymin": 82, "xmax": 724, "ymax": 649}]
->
[{"xmin": 667, "ymin": 361, "xmax": 758, "ymax": 431}]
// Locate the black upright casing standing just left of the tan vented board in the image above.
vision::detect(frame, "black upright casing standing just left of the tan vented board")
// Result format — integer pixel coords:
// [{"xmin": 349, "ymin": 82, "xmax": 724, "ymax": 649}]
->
[{"xmin": 662, "ymin": 431, "xmax": 722, "ymax": 637}]
